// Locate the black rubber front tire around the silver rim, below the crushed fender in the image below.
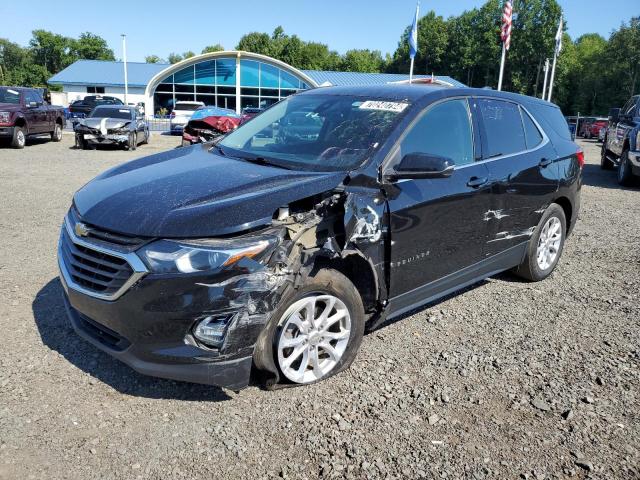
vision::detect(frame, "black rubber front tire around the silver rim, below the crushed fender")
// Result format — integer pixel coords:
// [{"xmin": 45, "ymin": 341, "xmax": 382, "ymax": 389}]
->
[{"xmin": 263, "ymin": 269, "xmax": 365, "ymax": 386}]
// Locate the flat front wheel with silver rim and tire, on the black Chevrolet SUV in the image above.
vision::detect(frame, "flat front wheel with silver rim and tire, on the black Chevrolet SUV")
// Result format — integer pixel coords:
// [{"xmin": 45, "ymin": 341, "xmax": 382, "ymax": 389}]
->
[{"xmin": 257, "ymin": 269, "xmax": 365, "ymax": 385}]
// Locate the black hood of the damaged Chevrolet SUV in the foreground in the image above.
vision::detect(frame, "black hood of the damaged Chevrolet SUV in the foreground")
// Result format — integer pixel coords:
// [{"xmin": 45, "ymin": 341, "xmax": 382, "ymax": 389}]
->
[{"xmin": 74, "ymin": 145, "xmax": 345, "ymax": 238}]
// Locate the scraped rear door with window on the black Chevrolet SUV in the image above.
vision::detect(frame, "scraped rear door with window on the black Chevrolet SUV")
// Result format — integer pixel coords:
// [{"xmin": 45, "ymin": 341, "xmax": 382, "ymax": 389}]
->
[{"xmin": 476, "ymin": 98, "xmax": 559, "ymax": 256}]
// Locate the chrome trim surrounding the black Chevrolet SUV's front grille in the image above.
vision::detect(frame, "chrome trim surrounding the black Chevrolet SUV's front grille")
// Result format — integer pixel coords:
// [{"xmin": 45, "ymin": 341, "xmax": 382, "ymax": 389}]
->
[{"xmin": 58, "ymin": 215, "xmax": 149, "ymax": 301}]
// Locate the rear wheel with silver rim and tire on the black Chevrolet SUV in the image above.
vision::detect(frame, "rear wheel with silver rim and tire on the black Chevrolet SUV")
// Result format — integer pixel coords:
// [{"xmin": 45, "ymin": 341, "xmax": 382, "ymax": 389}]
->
[{"xmin": 515, "ymin": 203, "xmax": 567, "ymax": 282}]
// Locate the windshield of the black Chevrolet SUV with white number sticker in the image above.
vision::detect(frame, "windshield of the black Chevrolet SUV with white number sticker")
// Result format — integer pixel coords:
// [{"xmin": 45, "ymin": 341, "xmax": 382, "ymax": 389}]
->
[{"xmin": 219, "ymin": 94, "xmax": 408, "ymax": 171}]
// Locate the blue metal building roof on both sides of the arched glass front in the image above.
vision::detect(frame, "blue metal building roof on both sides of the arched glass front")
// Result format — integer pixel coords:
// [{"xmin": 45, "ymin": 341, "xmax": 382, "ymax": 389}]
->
[{"xmin": 49, "ymin": 60, "xmax": 465, "ymax": 87}]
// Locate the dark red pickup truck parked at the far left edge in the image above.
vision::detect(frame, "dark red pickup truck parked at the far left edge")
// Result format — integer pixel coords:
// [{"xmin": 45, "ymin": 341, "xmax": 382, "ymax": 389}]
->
[{"xmin": 0, "ymin": 87, "xmax": 64, "ymax": 148}]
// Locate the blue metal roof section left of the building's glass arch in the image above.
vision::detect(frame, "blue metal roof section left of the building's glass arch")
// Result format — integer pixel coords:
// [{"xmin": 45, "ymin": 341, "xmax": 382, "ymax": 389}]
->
[{"xmin": 49, "ymin": 60, "xmax": 170, "ymax": 87}]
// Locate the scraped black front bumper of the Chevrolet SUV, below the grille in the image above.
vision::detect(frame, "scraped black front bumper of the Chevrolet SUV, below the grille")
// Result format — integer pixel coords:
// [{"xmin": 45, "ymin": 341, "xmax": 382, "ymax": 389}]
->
[{"xmin": 59, "ymin": 251, "xmax": 284, "ymax": 390}]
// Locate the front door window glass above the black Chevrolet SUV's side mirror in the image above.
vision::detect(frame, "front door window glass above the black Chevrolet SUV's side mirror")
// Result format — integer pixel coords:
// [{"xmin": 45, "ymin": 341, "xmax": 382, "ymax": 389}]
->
[{"xmin": 400, "ymin": 99, "xmax": 474, "ymax": 166}]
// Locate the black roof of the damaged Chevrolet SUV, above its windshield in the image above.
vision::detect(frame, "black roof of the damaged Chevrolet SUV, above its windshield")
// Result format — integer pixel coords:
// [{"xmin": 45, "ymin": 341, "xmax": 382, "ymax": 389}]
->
[{"xmin": 298, "ymin": 84, "xmax": 555, "ymax": 106}]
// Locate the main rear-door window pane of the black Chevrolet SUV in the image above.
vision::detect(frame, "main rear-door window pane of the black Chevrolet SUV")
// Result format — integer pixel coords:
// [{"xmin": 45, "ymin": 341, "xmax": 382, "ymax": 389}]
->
[{"xmin": 478, "ymin": 99, "xmax": 527, "ymax": 158}]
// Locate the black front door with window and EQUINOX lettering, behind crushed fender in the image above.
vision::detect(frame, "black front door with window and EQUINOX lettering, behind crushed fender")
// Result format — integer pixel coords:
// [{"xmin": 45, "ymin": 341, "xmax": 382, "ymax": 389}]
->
[{"xmin": 387, "ymin": 99, "xmax": 491, "ymax": 303}]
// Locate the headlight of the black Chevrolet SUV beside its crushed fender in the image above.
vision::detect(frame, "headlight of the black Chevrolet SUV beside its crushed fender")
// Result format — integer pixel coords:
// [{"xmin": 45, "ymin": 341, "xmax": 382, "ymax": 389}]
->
[{"xmin": 138, "ymin": 235, "xmax": 277, "ymax": 273}]
